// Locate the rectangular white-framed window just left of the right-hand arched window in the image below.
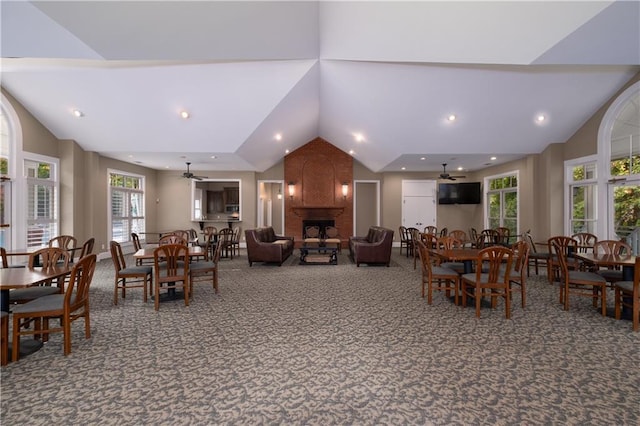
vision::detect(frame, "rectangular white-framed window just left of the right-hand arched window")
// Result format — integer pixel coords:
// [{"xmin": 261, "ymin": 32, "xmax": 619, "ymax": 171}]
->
[{"xmin": 565, "ymin": 157, "xmax": 598, "ymax": 235}]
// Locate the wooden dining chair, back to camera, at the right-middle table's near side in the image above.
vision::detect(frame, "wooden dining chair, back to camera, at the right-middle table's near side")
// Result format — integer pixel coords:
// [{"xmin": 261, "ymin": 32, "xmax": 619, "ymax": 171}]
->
[{"xmin": 461, "ymin": 245, "xmax": 513, "ymax": 319}]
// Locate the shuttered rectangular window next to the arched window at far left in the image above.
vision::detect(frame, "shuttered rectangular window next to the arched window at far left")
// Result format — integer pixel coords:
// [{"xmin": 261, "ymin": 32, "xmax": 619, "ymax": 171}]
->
[{"xmin": 24, "ymin": 156, "xmax": 59, "ymax": 249}]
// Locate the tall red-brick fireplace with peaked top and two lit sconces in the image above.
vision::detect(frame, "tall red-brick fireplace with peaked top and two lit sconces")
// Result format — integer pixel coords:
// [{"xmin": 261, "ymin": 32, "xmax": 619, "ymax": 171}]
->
[{"xmin": 284, "ymin": 138, "xmax": 353, "ymax": 246}]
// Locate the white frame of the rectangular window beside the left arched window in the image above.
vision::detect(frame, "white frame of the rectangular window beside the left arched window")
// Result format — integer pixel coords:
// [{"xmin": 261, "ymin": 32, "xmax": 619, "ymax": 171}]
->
[{"xmin": 19, "ymin": 152, "xmax": 60, "ymax": 249}]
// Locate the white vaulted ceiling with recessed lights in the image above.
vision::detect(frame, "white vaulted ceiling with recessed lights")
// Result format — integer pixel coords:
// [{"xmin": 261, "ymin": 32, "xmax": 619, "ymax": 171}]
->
[{"xmin": 0, "ymin": 0, "xmax": 640, "ymax": 172}]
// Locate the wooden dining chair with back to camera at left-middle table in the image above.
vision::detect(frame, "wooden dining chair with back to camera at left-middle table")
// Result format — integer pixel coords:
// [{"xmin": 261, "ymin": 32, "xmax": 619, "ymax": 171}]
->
[{"xmin": 153, "ymin": 244, "xmax": 190, "ymax": 311}]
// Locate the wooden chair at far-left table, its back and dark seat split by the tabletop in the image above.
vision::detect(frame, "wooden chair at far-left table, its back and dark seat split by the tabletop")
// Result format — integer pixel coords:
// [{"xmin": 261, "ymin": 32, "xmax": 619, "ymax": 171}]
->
[{"xmin": 9, "ymin": 247, "xmax": 71, "ymax": 304}]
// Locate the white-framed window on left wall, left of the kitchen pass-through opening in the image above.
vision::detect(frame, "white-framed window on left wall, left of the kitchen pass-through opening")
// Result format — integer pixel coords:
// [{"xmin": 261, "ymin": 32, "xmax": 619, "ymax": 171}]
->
[{"xmin": 109, "ymin": 171, "xmax": 145, "ymax": 243}]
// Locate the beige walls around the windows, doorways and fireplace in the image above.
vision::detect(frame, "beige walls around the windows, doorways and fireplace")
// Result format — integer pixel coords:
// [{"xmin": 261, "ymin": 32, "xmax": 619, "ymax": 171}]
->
[{"xmin": 2, "ymin": 73, "xmax": 640, "ymax": 251}]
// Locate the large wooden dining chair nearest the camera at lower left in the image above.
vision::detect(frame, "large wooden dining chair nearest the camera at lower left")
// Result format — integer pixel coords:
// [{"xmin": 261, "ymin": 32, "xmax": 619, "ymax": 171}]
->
[{"xmin": 11, "ymin": 254, "xmax": 96, "ymax": 361}]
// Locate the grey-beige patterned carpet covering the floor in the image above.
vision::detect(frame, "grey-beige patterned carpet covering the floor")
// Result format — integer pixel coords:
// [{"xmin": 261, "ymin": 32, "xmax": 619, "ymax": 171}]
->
[{"xmin": 0, "ymin": 248, "xmax": 640, "ymax": 426}]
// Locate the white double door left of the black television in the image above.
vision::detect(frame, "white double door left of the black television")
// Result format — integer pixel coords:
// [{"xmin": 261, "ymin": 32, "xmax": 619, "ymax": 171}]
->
[{"xmin": 402, "ymin": 180, "xmax": 438, "ymax": 231}]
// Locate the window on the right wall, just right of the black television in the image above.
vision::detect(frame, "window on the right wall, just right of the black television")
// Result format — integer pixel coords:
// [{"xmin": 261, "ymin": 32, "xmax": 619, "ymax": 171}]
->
[{"xmin": 485, "ymin": 172, "xmax": 518, "ymax": 235}]
